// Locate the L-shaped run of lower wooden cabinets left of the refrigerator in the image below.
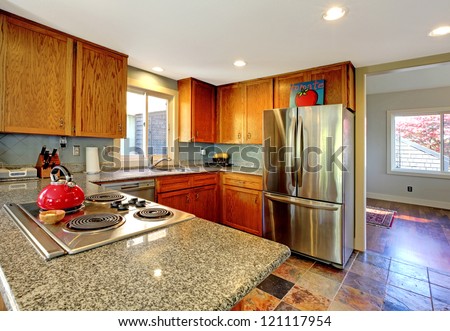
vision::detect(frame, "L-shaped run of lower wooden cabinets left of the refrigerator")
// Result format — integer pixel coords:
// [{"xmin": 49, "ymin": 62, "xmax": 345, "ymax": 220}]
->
[{"xmin": 156, "ymin": 173, "xmax": 262, "ymax": 232}]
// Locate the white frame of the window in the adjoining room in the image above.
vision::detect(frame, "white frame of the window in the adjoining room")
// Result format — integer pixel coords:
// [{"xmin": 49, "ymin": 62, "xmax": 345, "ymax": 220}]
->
[{"xmin": 386, "ymin": 107, "xmax": 450, "ymax": 179}]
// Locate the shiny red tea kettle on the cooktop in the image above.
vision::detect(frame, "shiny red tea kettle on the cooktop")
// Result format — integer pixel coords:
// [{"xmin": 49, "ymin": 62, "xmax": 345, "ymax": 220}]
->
[{"xmin": 37, "ymin": 165, "xmax": 84, "ymax": 211}]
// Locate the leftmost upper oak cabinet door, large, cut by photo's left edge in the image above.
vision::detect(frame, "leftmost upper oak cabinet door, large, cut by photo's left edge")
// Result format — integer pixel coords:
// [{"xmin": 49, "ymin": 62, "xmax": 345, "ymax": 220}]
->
[{"xmin": 0, "ymin": 15, "xmax": 73, "ymax": 135}]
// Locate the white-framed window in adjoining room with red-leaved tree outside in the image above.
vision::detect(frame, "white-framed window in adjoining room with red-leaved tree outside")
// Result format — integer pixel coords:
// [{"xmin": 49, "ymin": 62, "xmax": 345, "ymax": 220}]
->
[{"xmin": 388, "ymin": 108, "xmax": 450, "ymax": 177}]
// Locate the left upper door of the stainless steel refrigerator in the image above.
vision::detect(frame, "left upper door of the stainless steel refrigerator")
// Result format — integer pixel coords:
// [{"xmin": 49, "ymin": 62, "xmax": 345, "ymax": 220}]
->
[{"xmin": 263, "ymin": 108, "xmax": 297, "ymax": 196}]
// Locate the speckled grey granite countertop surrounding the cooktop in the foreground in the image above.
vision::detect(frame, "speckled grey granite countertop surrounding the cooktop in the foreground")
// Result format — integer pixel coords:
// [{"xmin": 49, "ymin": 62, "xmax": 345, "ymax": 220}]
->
[{"xmin": 0, "ymin": 174, "xmax": 290, "ymax": 311}]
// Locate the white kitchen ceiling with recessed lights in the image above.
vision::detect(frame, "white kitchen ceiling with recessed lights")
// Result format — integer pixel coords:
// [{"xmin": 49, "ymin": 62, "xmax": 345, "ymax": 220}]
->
[{"xmin": 0, "ymin": 0, "xmax": 450, "ymax": 85}]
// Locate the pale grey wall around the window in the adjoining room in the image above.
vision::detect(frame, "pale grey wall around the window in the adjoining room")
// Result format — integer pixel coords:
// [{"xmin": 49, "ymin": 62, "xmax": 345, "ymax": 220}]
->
[{"xmin": 367, "ymin": 87, "xmax": 450, "ymax": 209}]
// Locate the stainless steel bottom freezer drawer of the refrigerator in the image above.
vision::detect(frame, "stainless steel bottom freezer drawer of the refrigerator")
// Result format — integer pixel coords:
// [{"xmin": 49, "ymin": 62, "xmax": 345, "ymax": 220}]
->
[{"xmin": 263, "ymin": 192, "xmax": 346, "ymax": 267}]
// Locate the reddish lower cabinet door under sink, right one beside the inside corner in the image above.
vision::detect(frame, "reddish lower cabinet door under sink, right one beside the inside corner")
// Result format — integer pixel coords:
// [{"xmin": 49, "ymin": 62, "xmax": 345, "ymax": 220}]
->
[{"xmin": 192, "ymin": 185, "xmax": 218, "ymax": 222}]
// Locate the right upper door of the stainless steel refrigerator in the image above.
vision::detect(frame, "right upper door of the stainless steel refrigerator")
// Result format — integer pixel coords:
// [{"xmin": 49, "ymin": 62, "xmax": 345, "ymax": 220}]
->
[{"xmin": 296, "ymin": 105, "xmax": 348, "ymax": 203}]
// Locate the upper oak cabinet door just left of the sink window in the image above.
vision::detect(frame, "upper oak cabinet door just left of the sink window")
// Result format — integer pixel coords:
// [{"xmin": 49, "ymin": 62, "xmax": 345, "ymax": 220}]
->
[{"xmin": 75, "ymin": 42, "xmax": 127, "ymax": 138}]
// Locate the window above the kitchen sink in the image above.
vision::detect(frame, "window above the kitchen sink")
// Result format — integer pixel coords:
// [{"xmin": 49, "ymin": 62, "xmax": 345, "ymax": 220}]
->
[{"xmin": 120, "ymin": 88, "xmax": 174, "ymax": 165}]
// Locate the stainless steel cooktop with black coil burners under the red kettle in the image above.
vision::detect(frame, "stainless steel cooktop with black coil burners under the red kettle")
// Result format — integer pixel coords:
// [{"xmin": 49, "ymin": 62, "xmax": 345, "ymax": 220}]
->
[{"xmin": 4, "ymin": 192, "xmax": 195, "ymax": 259}]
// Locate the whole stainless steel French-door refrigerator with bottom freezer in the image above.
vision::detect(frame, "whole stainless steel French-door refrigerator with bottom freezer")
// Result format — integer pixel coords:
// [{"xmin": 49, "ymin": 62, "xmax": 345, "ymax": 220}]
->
[{"xmin": 263, "ymin": 105, "xmax": 355, "ymax": 268}]
